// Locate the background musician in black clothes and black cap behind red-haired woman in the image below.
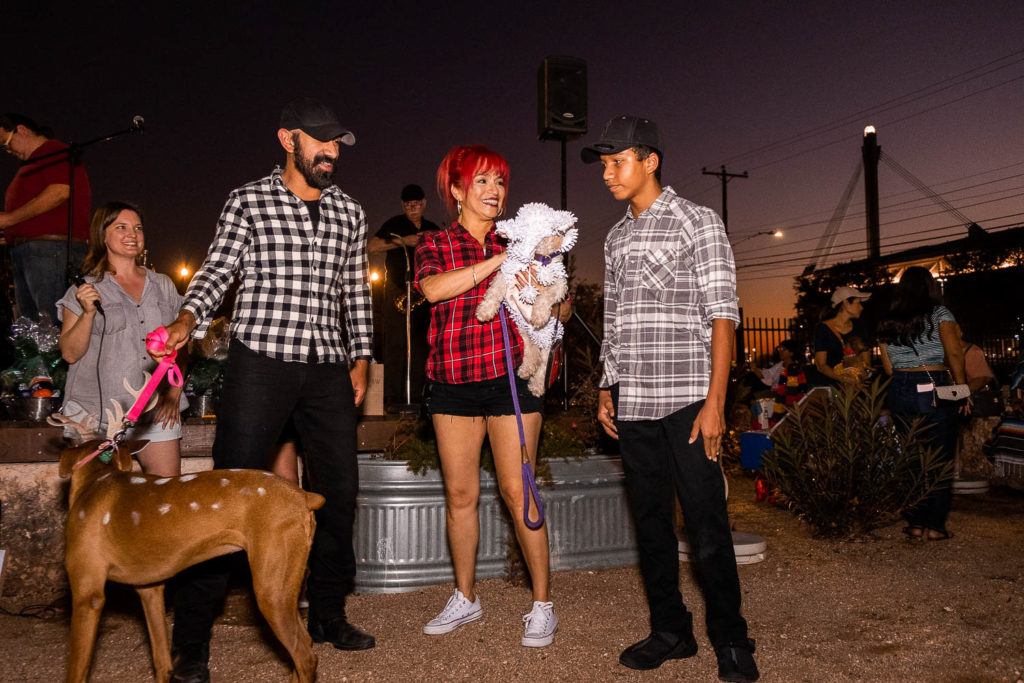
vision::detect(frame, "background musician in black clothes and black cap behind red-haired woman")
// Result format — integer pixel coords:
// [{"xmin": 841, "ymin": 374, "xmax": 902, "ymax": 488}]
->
[{"xmin": 367, "ymin": 184, "xmax": 440, "ymax": 410}]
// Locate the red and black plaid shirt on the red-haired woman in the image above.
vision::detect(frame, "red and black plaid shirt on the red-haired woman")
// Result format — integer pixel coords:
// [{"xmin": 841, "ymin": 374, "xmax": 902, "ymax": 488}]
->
[{"xmin": 416, "ymin": 224, "xmax": 522, "ymax": 384}]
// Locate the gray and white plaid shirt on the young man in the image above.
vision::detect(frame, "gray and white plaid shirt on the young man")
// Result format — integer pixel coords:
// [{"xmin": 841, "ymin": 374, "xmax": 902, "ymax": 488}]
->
[{"xmin": 601, "ymin": 186, "xmax": 739, "ymax": 420}]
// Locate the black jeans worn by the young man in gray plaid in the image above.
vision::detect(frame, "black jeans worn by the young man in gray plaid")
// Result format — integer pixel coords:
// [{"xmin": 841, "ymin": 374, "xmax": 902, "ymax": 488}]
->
[{"xmin": 612, "ymin": 390, "xmax": 746, "ymax": 647}]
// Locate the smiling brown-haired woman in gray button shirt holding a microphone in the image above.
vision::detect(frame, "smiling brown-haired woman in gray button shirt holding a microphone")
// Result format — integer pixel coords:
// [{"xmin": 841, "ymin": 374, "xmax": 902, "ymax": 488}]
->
[{"xmin": 57, "ymin": 202, "xmax": 187, "ymax": 476}]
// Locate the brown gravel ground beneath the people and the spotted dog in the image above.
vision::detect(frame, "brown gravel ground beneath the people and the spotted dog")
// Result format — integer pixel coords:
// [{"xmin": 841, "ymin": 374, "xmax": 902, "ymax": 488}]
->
[{"xmin": 0, "ymin": 477, "xmax": 1024, "ymax": 682}]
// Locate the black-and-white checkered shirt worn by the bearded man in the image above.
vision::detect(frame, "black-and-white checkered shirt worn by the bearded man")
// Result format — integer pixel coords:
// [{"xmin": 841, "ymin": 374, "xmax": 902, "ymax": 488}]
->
[{"xmin": 182, "ymin": 168, "xmax": 373, "ymax": 362}]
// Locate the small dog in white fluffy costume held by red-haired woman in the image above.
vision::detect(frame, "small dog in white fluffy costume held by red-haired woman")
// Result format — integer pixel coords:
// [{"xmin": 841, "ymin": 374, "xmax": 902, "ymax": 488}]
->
[{"xmin": 476, "ymin": 203, "xmax": 578, "ymax": 396}]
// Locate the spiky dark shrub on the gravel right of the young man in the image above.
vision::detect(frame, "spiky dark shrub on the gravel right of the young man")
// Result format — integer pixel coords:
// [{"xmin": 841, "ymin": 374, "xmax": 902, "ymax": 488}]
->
[{"xmin": 761, "ymin": 380, "xmax": 952, "ymax": 537}]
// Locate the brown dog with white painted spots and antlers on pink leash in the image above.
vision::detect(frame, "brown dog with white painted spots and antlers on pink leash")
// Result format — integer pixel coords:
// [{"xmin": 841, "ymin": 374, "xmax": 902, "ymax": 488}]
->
[{"xmin": 54, "ymin": 403, "xmax": 324, "ymax": 682}]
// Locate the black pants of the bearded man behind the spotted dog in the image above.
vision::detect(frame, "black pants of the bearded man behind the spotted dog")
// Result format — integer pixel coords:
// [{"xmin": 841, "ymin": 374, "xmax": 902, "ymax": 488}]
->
[{"xmin": 173, "ymin": 340, "xmax": 358, "ymax": 648}]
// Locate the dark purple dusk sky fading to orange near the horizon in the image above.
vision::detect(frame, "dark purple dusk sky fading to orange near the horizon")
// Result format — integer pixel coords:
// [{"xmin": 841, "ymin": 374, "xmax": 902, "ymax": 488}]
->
[{"xmin": 0, "ymin": 0, "xmax": 1024, "ymax": 323}]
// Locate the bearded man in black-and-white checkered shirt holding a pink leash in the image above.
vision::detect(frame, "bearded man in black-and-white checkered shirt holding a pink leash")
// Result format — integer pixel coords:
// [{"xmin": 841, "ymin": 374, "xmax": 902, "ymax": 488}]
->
[{"xmin": 151, "ymin": 97, "xmax": 375, "ymax": 683}]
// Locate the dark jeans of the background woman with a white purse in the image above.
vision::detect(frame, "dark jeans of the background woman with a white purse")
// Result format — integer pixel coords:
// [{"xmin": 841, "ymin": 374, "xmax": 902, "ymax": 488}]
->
[{"xmin": 888, "ymin": 371, "xmax": 959, "ymax": 531}]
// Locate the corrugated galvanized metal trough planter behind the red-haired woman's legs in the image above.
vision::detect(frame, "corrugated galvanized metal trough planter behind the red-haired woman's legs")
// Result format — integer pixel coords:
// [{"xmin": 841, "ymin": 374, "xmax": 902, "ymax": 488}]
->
[{"xmin": 354, "ymin": 456, "xmax": 637, "ymax": 593}]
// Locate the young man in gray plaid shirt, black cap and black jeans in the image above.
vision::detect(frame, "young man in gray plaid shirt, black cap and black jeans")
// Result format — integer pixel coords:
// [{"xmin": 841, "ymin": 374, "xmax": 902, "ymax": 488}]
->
[{"xmin": 582, "ymin": 116, "xmax": 759, "ymax": 681}]
